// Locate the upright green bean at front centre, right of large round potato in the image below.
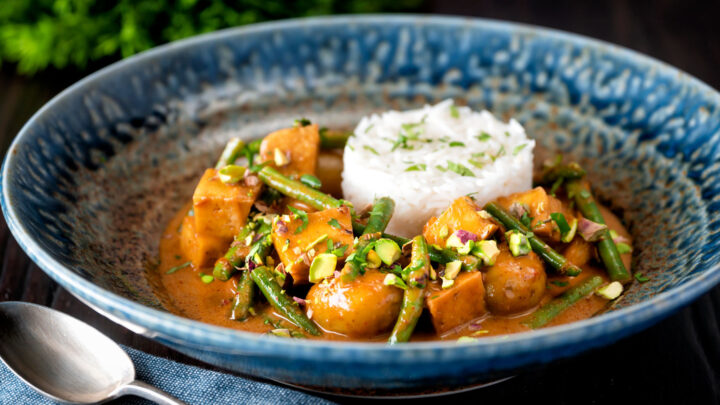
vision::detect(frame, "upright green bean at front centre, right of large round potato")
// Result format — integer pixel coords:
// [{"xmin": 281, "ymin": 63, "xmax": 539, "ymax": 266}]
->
[{"xmin": 388, "ymin": 235, "xmax": 430, "ymax": 344}]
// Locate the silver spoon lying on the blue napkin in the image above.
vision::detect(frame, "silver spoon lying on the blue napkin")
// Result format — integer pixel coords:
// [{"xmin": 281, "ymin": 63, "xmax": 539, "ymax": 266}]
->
[{"xmin": 0, "ymin": 302, "xmax": 184, "ymax": 405}]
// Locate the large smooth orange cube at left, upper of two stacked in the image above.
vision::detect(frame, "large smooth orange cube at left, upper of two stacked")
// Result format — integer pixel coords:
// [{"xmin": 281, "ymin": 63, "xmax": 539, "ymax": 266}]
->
[{"xmin": 193, "ymin": 169, "xmax": 262, "ymax": 239}]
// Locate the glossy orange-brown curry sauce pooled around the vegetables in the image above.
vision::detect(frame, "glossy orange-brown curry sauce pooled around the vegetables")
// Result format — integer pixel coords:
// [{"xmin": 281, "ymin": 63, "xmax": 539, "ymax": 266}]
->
[{"xmin": 155, "ymin": 196, "xmax": 631, "ymax": 342}]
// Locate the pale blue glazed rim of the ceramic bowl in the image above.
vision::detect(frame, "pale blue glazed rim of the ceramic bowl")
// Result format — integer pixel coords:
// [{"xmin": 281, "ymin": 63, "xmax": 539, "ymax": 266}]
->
[{"xmin": 0, "ymin": 14, "xmax": 720, "ymax": 362}]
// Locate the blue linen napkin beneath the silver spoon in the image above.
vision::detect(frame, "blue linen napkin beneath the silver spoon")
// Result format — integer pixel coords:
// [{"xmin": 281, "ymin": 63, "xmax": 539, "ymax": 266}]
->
[{"xmin": 0, "ymin": 347, "xmax": 332, "ymax": 405}]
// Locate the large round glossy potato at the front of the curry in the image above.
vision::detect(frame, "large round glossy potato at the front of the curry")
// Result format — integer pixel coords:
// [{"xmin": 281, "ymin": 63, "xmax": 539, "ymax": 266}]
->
[{"xmin": 306, "ymin": 270, "xmax": 403, "ymax": 338}]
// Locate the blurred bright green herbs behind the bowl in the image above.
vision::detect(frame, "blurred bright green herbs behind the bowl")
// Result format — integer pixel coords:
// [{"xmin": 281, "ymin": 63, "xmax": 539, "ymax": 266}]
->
[{"xmin": 0, "ymin": 0, "xmax": 424, "ymax": 75}]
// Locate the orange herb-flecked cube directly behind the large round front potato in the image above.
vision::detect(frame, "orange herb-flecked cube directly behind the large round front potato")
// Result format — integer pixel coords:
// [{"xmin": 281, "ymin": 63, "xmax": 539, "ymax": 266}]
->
[{"xmin": 272, "ymin": 206, "xmax": 354, "ymax": 284}]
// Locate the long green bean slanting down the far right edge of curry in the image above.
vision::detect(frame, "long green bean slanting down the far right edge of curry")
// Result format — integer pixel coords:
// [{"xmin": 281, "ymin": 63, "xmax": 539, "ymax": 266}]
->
[{"xmin": 565, "ymin": 180, "xmax": 632, "ymax": 284}]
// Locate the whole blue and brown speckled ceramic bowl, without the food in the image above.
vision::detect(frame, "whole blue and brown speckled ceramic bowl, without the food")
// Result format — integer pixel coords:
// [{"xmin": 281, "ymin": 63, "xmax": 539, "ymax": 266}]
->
[{"xmin": 2, "ymin": 16, "xmax": 720, "ymax": 389}]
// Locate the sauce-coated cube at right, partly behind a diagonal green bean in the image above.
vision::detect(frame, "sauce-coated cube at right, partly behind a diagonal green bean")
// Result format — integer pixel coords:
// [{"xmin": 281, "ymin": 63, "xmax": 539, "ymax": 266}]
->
[{"xmin": 498, "ymin": 187, "xmax": 575, "ymax": 242}]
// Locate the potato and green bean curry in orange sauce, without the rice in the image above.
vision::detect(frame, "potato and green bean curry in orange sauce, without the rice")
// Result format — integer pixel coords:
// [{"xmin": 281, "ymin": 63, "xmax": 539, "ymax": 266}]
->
[{"xmin": 157, "ymin": 120, "xmax": 632, "ymax": 344}]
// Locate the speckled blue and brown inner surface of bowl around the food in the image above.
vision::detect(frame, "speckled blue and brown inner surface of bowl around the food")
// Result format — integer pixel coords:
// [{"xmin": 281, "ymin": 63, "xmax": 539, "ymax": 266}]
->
[{"xmin": 4, "ymin": 17, "xmax": 720, "ymax": 326}]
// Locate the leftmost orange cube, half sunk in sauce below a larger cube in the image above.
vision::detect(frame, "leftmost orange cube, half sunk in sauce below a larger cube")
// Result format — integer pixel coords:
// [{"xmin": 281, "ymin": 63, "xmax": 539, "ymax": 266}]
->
[{"xmin": 180, "ymin": 216, "xmax": 232, "ymax": 269}]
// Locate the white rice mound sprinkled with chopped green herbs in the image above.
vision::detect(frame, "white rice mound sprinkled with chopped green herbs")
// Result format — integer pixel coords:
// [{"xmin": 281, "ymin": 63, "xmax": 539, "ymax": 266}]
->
[{"xmin": 342, "ymin": 100, "xmax": 535, "ymax": 237}]
